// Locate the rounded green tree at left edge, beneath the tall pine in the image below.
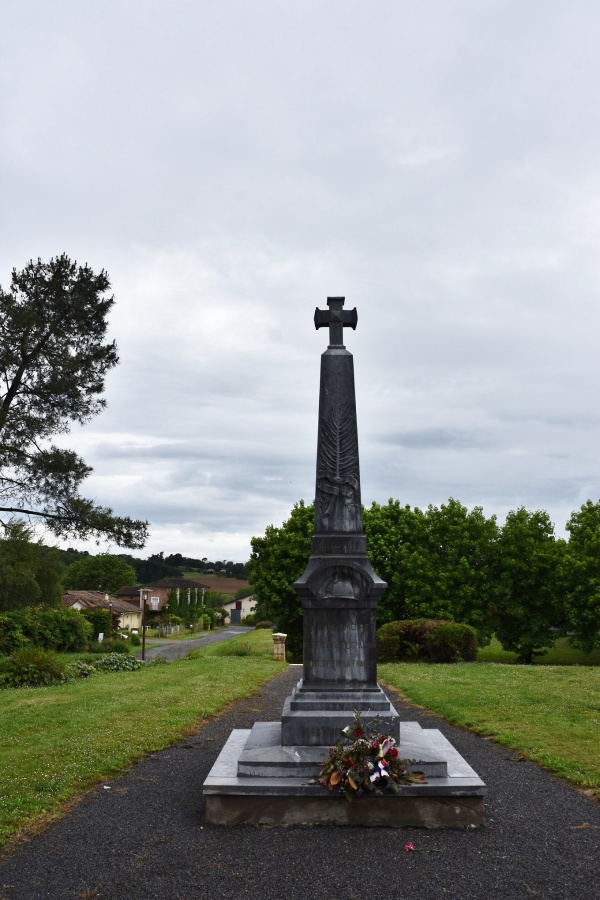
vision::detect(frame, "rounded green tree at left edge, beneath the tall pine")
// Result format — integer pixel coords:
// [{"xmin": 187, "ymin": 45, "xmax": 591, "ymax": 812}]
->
[{"xmin": 0, "ymin": 522, "xmax": 63, "ymax": 610}]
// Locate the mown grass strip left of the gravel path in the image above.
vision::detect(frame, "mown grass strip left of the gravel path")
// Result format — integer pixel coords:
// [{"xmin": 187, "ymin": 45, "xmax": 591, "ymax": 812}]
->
[{"xmin": 0, "ymin": 631, "xmax": 285, "ymax": 842}]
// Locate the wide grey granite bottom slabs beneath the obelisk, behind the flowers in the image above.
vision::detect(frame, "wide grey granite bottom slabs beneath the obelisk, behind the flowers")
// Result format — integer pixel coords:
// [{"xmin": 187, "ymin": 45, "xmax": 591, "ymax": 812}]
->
[{"xmin": 203, "ymin": 722, "xmax": 486, "ymax": 828}]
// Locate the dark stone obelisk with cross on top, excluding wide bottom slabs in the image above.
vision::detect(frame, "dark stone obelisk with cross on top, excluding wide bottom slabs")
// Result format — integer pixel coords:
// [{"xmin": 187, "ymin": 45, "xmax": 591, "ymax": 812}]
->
[{"xmin": 282, "ymin": 297, "xmax": 399, "ymax": 746}]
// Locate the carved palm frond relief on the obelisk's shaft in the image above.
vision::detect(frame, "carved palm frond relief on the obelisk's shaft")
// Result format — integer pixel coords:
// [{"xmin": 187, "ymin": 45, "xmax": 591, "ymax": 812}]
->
[{"xmin": 315, "ymin": 401, "xmax": 362, "ymax": 533}]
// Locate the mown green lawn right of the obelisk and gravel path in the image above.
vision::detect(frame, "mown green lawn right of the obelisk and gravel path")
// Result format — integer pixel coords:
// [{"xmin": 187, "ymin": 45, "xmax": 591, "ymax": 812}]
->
[{"xmin": 379, "ymin": 663, "xmax": 600, "ymax": 797}]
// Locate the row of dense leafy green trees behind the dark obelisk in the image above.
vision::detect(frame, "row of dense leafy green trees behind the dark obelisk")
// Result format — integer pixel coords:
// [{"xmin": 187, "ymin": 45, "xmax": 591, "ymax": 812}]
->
[{"xmin": 248, "ymin": 498, "xmax": 588, "ymax": 662}]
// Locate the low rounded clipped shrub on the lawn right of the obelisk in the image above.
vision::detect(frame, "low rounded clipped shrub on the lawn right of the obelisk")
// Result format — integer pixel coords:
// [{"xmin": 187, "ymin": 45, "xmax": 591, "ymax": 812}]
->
[{"xmin": 377, "ymin": 619, "xmax": 477, "ymax": 663}]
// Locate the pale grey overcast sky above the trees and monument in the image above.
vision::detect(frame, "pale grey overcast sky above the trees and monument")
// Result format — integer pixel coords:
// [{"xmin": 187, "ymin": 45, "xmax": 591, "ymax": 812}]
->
[{"xmin": 0, "ymin": 0, "xmax": 600, "ymax": 561}]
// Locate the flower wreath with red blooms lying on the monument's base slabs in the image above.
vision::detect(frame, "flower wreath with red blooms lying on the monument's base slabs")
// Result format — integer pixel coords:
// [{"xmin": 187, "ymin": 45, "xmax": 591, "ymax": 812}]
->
[{"xmin": 320, "ymin": 709, "xmax": 425, "ymax": 800}]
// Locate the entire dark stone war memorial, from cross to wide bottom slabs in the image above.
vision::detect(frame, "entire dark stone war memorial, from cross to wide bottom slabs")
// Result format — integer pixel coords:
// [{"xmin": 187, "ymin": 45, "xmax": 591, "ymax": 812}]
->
[{"xmin": 203, "ymin": 297, "xmax": 486, "ymax": 828}]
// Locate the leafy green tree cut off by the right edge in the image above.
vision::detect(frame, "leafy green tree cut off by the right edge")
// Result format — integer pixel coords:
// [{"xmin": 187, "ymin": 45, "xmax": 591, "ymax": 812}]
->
[{"xmin": 563, "ymin": 500, "xmax": 600, "ymax": 652}]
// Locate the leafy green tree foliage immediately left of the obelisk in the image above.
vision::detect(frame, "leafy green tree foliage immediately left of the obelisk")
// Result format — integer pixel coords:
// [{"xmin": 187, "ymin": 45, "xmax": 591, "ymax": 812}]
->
[{"xmin": 248, "ymin": 500, "xmax": 314, "ymax": 658}]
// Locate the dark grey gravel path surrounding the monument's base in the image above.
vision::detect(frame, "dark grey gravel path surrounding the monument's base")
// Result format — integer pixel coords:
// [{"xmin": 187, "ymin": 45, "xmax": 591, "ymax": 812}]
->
[{"xmin": 0, "ymin": 667, "xmax": 600, "ymax": 900}]
